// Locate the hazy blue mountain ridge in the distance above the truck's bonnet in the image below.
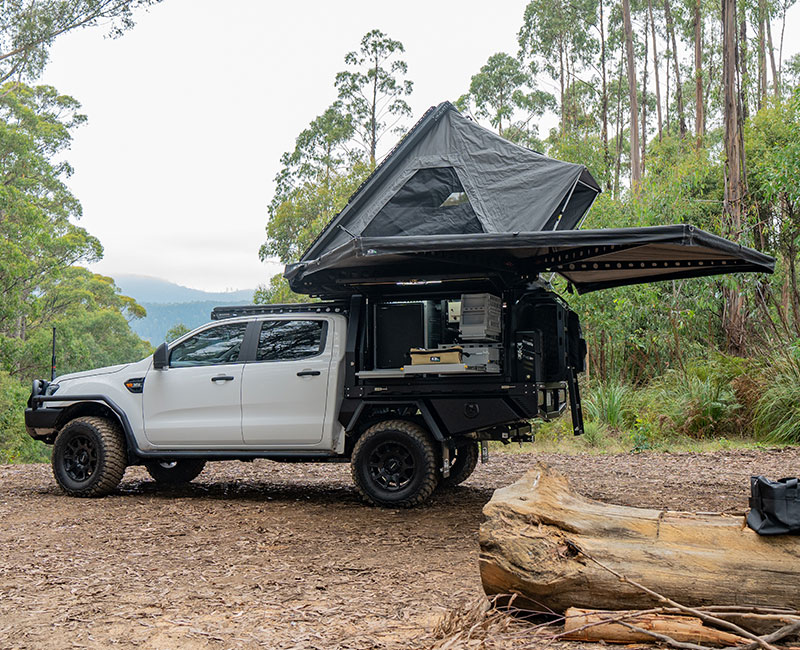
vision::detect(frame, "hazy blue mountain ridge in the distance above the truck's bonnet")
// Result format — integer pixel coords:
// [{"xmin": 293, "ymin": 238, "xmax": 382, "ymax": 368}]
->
[{"xmin": 114, "ymin": 275, "xmax": 255, "ymax": 345}]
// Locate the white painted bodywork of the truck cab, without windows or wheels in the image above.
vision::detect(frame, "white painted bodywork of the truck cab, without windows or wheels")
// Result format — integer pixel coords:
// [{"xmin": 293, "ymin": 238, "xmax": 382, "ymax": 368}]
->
[{"xmin": 49, "ymin": 313, "xmax": 347, "ymax": 454}]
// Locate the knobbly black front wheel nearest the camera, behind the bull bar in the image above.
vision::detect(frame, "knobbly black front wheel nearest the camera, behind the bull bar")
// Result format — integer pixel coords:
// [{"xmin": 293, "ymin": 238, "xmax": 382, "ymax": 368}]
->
[{"xmin": 52, "ymin": 417, "xmax": 127, "ymax": 497}]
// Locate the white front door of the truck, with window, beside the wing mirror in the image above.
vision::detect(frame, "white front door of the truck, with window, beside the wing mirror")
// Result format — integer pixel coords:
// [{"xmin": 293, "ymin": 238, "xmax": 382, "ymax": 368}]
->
[{"xmin": 143, "ymin": 323, "xmax": 247, "ymax": 448}]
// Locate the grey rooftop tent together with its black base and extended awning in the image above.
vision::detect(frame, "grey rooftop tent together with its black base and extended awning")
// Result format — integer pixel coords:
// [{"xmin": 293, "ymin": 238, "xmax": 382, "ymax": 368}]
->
[{"xmin": 284, "ymin": 102, "xmax": 774, "ymax": 297}]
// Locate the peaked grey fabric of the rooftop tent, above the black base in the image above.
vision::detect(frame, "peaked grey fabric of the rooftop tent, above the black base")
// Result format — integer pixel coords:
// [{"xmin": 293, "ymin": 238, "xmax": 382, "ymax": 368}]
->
[{"xmin": 301, "ymin": 102, "xmax": 600, "ymax": 262}]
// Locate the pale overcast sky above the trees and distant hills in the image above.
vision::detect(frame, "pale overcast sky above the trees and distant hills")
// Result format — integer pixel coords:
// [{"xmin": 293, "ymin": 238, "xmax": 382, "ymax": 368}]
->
[{"xmin": 41, "ymin": 0, "xmax": 800, "ymax": 291}]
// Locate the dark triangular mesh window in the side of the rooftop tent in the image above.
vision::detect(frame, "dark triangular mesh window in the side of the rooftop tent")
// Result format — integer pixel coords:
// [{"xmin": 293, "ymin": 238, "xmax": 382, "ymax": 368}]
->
[{"xmin": 362, "ymin": 167, "xmax": 483, "ymax": 237}]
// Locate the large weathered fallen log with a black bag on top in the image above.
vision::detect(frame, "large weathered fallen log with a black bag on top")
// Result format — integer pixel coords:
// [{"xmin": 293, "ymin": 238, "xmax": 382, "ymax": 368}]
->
[{"xmin": 480, "ymin": 465, "xmax": 800, "ymax": 613}]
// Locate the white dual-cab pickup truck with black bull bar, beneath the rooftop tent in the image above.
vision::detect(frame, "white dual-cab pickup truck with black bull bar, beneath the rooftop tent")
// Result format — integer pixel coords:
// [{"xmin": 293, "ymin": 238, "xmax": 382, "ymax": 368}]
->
[{"xmin": 26, "ymin": 298, "xmax": 565, "ymax": 507}]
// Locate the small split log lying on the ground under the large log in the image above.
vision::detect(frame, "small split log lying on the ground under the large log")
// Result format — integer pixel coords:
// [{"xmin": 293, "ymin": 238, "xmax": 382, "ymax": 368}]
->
[{"xmin": 560, "ymin": 607, "xmax": 747, "ymax": 646}]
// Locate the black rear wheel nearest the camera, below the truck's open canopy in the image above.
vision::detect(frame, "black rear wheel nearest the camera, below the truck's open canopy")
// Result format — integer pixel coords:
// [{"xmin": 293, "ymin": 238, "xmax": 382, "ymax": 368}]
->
[{"xmin": 350, "ymin": 420, "xmax": 439, "ymax": 508}]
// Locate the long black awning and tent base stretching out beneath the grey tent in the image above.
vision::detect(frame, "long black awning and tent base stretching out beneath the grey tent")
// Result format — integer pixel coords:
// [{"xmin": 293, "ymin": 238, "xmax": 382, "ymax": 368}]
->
[{"xmin": 285, "ymin": 225, "xmax": 775, "ymax": 297}]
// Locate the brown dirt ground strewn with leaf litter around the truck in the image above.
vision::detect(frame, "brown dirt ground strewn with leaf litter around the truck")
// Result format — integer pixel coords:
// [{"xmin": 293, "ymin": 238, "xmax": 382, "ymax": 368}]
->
[{"xmin": 0, "ymin": 448, "xmax": 800, "ymax": 650}]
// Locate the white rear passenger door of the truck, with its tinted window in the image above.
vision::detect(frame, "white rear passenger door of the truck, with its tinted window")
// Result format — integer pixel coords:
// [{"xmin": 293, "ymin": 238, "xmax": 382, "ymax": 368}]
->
[{"xmin": 242, "ymin": 317, "xmax": 334, "ymax": 448}]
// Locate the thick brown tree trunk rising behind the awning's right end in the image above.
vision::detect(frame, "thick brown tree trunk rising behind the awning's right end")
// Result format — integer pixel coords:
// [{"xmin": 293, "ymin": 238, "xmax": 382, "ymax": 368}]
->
[{"xmin": 722, "ymin": 0, "xmax": 745, "ymax": 354}]
